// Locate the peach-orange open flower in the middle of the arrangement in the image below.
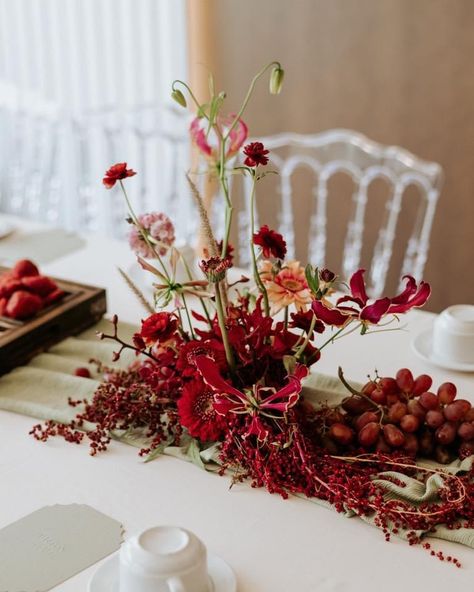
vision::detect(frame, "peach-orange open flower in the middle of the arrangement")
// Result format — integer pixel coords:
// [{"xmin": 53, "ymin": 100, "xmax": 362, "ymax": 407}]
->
[{"xmin": 260, "ymin": 261, "xmax": 312, "ymax": 314}]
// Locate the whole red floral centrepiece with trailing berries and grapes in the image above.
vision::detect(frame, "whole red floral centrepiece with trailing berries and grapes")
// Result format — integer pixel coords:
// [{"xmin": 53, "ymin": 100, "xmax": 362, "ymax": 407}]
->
[{"xmin": 32, "ymin": 62, "xmax": 474, "ymax": 566}]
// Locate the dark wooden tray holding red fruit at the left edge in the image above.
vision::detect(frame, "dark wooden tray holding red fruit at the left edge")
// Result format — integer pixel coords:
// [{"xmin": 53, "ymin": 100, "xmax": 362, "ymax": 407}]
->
[{"xmin": 0, "ymin": 267, "xmax": 107, "ymax": 375}]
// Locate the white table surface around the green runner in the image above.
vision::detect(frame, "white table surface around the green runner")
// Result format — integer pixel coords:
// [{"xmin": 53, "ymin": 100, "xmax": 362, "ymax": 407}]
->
[{"xmin": 0, "ymin": 215, "xmax": 474, "ymax": 592}]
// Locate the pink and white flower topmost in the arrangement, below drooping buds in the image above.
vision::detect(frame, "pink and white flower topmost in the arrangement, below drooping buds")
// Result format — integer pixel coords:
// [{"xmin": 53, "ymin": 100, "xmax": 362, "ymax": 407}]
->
[{"xmin": 189, "ymin": 115, "xmax": 248, "ymax": 161}]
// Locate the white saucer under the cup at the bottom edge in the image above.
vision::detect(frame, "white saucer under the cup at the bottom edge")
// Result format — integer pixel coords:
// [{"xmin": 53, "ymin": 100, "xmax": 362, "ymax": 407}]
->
[{"xmin": 87, "ymin": 553, "xmax": 237, "ymax": 592}]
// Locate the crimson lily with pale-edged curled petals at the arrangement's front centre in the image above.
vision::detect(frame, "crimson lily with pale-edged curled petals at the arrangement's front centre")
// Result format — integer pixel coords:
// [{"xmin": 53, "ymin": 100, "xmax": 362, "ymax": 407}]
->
[{"xmin": 196, "ymin": 356, "xmax": 308, "ymax": 440}]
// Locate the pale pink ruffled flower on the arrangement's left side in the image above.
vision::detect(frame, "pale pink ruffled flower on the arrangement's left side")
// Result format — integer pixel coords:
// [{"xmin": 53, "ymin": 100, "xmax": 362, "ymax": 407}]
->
[{"xmin": 128, "ymin": 212, "xmax": 175, "ymax": 258}]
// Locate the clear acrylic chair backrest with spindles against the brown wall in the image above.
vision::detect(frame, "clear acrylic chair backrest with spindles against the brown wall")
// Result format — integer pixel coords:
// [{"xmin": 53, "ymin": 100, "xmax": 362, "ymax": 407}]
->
[{"xmin": 239, "ymin": 129, "xmax": 442, "ymax": 297}]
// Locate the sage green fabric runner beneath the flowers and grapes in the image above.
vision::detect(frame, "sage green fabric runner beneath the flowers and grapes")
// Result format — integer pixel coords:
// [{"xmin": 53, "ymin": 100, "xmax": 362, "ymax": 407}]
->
[{"xmin": 0, "ymin": 320, "xmax": 474, "ymax": 548}]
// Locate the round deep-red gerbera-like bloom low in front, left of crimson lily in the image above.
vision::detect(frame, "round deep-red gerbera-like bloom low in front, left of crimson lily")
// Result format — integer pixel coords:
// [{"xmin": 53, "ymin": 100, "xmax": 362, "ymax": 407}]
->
[{"xmin": 178, "ymin": 380, "xmax": 227, "ymax": 442}]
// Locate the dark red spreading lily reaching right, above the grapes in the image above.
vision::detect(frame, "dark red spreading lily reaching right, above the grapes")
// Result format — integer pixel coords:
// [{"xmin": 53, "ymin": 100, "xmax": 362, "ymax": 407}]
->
[{"xmin": 311, "ymin": 269, "xmax": 431, "ymax": 327}]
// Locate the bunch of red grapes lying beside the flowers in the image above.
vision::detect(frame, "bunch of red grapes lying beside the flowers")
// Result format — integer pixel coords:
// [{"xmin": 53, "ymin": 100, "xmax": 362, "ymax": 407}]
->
[{"xmin": 325, "ymin": 368, "xmax": 474, "ymax": 464}]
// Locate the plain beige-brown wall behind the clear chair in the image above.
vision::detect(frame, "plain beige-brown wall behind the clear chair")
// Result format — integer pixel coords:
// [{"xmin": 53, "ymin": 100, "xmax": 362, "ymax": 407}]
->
[{"xmin": 190, "ymin": 0, "xmax": 474, "ymax": 310}]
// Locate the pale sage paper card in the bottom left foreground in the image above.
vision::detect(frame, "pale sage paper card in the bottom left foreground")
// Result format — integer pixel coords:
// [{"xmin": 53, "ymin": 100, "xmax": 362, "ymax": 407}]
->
[{"xmin": 0, "ymin": 504, "xmax": 123, "ymax": 592}]
